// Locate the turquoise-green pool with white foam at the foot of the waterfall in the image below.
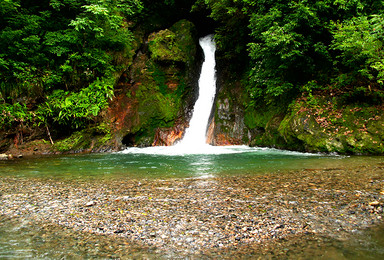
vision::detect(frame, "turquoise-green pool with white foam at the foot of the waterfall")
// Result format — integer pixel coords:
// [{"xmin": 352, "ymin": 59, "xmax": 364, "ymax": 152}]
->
[{"xmin": 0, "ymin": 147, "xmax": 384, "ymax": 179}]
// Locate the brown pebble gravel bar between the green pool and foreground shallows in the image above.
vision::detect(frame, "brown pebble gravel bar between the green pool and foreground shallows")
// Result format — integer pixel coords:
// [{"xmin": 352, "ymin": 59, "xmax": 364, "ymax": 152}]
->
[{"xmin": 0, "ymin": 164, "xmax": 384, "ymax": 257}]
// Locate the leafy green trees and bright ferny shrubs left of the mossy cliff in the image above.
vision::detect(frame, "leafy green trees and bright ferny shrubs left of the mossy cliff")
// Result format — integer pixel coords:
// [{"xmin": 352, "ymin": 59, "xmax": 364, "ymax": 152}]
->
[{"xmin": 0, "ymin": 0, "xmax": 143, "ymax": 128}]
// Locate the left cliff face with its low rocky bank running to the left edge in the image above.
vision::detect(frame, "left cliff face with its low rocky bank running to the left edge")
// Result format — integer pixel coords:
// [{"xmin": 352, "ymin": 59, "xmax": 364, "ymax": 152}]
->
[{"xmin": 0, "ymin": 20, "xmax": 202, "ymax": 155}]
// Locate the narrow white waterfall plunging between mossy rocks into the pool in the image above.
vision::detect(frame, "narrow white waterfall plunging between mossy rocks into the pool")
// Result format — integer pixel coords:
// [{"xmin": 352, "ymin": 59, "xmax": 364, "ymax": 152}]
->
[{"xmin": 177, "ymin": 35, "xmax": 216, "ymax": 149}]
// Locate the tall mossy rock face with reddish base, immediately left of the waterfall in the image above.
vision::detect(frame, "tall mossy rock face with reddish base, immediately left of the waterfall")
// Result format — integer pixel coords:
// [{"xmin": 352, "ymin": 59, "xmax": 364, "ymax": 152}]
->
[{"xmin": 106, "ymin": 20, "xmax": 201, "ymax": 146}]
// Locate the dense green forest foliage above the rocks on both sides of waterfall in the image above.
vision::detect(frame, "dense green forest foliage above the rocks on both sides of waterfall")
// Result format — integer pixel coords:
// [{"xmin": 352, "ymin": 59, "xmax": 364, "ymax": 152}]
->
[{"xmin": 0, "ymin": 0, "xmax": 384, "ymax": 151}]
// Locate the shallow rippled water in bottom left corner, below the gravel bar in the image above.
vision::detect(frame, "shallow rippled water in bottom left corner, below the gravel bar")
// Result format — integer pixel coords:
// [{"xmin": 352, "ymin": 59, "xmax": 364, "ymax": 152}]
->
[{"xmin": 0, "ymin": 217, "xmax": 155, "ymax": 259}]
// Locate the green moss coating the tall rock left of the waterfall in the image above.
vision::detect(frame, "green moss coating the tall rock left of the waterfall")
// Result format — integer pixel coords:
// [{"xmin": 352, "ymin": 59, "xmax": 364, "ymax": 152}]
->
[{"xmin": 113, "ymin": 20, "xmax": 197, "ymax": 146}]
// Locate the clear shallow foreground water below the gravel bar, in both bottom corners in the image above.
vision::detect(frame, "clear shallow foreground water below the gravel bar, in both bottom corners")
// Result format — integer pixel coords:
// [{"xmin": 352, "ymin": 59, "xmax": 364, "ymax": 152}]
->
[{"xmin": 0, "ymin": 218, "xmax": 384, "ymax": 260}]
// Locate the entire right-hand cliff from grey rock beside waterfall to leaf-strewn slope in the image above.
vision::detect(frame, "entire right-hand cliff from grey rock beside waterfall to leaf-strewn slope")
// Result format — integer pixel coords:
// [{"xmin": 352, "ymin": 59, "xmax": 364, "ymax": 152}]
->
[{"xmin": 210, "ymin": 72, "xmax": 384, "ymax": 154}]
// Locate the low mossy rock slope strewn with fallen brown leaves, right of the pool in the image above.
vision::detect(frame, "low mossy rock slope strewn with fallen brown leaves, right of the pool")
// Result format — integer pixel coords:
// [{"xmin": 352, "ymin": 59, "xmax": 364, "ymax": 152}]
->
[{"xmin": 240, "ymin": 97, "xmax": 384, "ymax": 154}]
